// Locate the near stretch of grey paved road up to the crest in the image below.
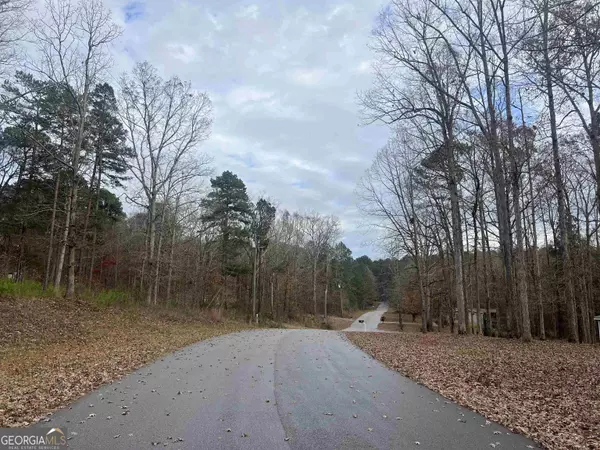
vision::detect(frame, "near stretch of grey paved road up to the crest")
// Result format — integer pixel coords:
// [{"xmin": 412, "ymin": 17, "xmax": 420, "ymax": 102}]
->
[{"xmin": 44, "ymin": 330, "xmax": 534, "ymax": 450}]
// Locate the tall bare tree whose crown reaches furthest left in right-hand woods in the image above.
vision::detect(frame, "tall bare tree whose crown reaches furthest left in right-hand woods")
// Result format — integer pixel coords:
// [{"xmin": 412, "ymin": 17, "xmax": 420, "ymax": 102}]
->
[{"xmin": 362, "ymin": 1, "xmax": 469, "ymax": 333}]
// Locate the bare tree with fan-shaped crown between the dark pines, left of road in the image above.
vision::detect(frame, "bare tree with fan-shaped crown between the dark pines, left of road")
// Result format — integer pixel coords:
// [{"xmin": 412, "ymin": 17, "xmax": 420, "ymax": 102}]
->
[{"xmin": 121, "ymin": 62, "xmax": 212, "ymax": 303}]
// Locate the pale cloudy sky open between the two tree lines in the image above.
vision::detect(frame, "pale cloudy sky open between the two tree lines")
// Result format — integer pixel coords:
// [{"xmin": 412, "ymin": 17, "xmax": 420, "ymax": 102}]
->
[{"xmin": 106, "ymin": 0, "xmax": 387, "ymax": 256}]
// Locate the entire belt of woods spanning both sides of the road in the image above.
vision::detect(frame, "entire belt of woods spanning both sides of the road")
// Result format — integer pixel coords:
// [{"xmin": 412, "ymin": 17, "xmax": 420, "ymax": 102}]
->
[{"xmin": 0, "ymin": 0, "xmax": 600, "ymax": 342}]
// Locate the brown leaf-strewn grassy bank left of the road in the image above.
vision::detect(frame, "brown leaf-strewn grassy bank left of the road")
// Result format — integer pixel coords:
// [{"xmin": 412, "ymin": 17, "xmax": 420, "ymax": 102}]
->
[{"xmin": 0, "ymin": 297, "xmax": 246, "ymax": 427}]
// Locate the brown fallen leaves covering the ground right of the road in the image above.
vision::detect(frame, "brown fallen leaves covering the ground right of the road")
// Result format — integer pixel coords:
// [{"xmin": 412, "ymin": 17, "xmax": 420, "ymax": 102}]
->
[{"xmin": 347, "ymin": 333, "xmax": 600, "ymax": 450}]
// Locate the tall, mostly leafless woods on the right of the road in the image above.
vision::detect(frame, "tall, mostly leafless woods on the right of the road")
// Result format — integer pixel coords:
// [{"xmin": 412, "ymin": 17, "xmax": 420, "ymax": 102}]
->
[{"xmin": 360, "ymin": 0, "xmax": 600, "ymax": 343}]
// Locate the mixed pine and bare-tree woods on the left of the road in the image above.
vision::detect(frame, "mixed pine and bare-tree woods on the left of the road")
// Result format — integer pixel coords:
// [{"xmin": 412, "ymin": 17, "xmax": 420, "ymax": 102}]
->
[{"xmin": 0, "ymin": 0, "xmax": 386, "ymax": 321}]
